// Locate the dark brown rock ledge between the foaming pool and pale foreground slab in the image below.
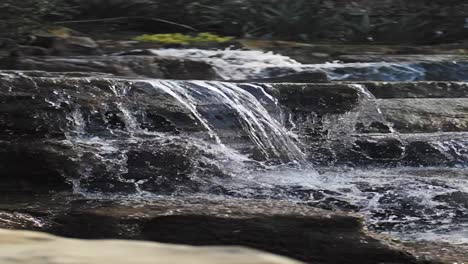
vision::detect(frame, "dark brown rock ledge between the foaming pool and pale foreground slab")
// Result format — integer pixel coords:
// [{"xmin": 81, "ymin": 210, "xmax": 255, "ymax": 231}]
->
[{"xmin": 0, "ymin": 198, "xmax": 432, "ymax": 264}]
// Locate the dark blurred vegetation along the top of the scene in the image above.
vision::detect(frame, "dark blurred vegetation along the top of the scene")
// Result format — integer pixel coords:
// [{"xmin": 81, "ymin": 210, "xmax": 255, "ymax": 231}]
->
[{"xmin": 0, "ymin": 0, "xmax": 468, "ymax": 44}]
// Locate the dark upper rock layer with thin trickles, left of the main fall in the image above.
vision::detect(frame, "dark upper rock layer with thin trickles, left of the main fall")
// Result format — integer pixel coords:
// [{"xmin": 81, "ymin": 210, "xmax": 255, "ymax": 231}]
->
[{"xmin": 0, "ymin": 72, "xmax": 203, "ymax": 139}]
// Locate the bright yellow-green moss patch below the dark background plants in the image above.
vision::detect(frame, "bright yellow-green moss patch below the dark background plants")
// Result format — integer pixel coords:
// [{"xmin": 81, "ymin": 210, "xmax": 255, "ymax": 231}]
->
[{"xmin": 133, "ymin": 32, "xmax": 233, "ymax": 44}]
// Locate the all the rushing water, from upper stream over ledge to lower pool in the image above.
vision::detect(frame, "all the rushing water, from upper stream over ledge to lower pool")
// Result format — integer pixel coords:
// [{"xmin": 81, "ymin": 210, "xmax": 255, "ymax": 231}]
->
[{"xmin": 0, "ymin": 49, "xmax": 468, "ymax": 248}]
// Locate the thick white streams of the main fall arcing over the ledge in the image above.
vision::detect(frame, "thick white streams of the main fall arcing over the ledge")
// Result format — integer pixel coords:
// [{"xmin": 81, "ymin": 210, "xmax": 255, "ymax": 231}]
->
[{"xmin": 147, "ymin": 80, "xmax": 305, "ymax": 162}]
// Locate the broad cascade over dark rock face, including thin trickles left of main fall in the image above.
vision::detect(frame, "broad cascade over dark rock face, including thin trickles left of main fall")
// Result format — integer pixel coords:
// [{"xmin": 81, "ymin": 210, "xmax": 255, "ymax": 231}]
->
[{"xmin": 31, "ymin": 75, "xmax": 305, "ymax": 195}]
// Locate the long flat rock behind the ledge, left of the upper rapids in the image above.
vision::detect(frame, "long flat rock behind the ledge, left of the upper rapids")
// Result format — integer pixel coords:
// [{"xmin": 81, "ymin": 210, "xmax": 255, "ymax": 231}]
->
[{"xmin": 0, "ymin": 56, "xmax": 219, "ymax": 80}]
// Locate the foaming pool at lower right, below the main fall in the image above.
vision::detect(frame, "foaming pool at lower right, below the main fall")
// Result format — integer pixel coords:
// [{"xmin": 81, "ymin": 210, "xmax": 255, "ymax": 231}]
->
[{"xmin": 215, "ymin": 167, "xmax": 468, "ymax": 243}]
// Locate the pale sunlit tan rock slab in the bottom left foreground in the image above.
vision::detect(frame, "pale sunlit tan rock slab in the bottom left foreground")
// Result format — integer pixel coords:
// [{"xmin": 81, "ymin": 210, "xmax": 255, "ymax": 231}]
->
[{"xmin": 0, "ymin": 229, "xmax": 300, "ymax": 264}]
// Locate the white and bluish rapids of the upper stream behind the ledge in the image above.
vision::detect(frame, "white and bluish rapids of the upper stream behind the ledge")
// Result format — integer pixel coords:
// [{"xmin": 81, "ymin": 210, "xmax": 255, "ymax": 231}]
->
[{"xmin": 148, "ymin": 49, "xmax": 468, "ymax": 82}]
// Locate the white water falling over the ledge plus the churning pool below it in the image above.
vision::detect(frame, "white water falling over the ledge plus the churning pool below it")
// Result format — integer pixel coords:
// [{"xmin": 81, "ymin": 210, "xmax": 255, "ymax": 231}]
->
[{"xmin": 51, "ymin": 75, "xmax": 468, "ymax": 243}]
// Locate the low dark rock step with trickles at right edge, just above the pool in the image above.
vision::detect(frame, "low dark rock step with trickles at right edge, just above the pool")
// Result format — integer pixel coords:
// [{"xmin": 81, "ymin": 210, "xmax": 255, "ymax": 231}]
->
[{"xmin": 330, "ymin": 132, "xmax": 468, "ymax": 166}]
